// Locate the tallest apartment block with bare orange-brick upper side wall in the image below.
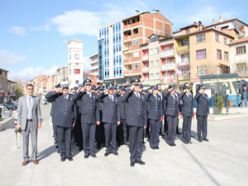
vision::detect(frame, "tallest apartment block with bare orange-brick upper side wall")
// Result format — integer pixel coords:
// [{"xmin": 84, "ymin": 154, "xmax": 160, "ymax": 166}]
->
[{"xmin": 122, "ymin": 12, "xmax": 172, "ymax": 81}]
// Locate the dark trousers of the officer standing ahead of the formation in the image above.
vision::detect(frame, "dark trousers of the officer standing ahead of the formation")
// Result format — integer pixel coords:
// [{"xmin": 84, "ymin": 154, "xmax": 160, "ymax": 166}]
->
[{"xmin": 128, "ymin": 126, "xmax": 144, "ymax": 163}]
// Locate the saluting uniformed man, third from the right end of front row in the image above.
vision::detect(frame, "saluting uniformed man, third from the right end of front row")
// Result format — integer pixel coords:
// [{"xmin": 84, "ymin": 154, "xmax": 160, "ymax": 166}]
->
[{"xmin": 166, "ymin": 85, "xmax": 179, "ymax": 146}]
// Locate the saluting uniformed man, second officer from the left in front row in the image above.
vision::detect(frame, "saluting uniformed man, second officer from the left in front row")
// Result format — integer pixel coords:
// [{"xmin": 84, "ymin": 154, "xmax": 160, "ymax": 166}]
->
[{"xmin": 74, "ymin": 79, "xmax": 100, "ymax": 158}]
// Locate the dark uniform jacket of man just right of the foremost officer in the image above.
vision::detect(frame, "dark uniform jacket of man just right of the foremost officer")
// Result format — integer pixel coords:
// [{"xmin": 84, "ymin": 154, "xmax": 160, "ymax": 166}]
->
[{"xmin": 145, "ymin": 93, "xmax": 163, "ymax": 120}]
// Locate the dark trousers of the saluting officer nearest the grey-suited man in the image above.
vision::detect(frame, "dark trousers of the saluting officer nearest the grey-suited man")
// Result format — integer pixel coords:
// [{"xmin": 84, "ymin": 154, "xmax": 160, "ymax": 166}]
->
[{"xmin": 57, "ymin": 126, "xmax": 72, "ymax": 158}]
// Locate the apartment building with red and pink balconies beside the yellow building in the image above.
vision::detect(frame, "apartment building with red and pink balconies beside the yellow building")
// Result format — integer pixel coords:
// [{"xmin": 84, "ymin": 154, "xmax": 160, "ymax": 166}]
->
[{"xmin": 141, "ymin": 34, "xmax": 177, "ymax": 85}]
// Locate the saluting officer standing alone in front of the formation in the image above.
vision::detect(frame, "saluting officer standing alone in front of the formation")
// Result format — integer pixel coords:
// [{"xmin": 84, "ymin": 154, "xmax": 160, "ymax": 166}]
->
[{"xmin": 123, "ymin": 79, "xmax": 147, "ymax": 167}]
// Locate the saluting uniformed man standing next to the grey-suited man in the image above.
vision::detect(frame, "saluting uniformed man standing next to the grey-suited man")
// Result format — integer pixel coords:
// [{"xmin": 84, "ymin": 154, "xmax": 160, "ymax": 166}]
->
[{"xmin": 46, "ymin": 83, "xmax": 77, "ymax": 161}]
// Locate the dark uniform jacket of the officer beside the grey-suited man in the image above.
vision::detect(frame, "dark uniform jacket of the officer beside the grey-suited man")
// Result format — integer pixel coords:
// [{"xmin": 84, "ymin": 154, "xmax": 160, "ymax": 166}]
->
[{"xmin": 46, "ymin": 92, "xmax": 77, "ymax": 128}]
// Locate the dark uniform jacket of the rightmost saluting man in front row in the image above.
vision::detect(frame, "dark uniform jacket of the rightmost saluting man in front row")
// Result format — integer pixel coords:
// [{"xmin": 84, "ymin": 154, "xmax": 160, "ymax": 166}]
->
[{"xmin": 194, "ymin": 92, "xmax": 209, "ymax": 116}]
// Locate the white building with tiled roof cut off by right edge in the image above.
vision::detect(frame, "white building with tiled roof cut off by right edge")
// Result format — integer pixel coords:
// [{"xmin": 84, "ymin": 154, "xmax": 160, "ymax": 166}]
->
[{"xmin": 229, "ymin": 37, "xmax": 248, "ymax": 77}]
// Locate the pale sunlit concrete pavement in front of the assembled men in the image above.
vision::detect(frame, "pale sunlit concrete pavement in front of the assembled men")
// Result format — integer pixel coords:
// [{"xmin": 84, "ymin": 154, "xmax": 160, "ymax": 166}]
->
[{"xmin": 0, "ymin": 105, "xmax": 248, "ymax": 186}]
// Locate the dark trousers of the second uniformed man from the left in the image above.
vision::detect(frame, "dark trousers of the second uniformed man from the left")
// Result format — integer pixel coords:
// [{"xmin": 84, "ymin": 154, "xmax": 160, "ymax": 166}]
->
[{"xmin": 82, "ymin": 123, "xmax": 96, "ymax": 155}]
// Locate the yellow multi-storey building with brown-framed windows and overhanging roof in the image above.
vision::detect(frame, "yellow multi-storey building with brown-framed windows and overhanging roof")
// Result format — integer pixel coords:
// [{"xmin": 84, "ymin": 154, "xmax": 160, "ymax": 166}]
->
[{"xmin": 174, "ymin": 23, "xmax": 234, "ymax": 82}]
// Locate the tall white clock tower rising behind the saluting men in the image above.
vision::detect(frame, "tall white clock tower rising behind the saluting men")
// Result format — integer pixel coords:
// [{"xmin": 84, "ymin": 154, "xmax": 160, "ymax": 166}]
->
[{"xmin": 67, "ymin": 40, "xmax": 83, "ymax": 88}]
